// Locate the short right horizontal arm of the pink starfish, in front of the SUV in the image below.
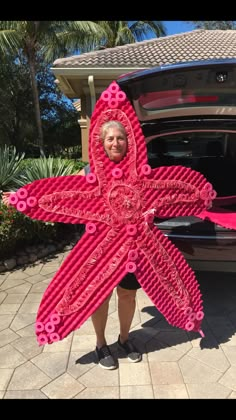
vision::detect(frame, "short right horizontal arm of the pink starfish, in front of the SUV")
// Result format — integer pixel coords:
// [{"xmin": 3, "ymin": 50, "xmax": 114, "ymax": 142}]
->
[{"xmin": 141, "ymin": 166, "xmax": 216, "ymax": 218}]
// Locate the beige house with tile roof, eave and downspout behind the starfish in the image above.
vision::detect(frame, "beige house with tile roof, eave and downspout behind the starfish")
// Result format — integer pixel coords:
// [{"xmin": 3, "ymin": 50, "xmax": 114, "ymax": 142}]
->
[{"xmin": 51, "ymin": 29, "xmax": 236, "ymax": 162}]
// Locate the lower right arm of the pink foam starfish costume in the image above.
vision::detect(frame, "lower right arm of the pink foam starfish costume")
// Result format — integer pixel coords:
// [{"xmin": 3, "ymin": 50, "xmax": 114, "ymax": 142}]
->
[{"xmin": 137, "ymin": 225, "xmax": 203, "ymax": 331}]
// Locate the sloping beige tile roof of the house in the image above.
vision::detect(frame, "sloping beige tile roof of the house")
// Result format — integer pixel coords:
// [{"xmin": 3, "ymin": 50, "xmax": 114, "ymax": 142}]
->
[{"xmin": 53, "ymin": 29, "xmax": 236, "ymax": 68}]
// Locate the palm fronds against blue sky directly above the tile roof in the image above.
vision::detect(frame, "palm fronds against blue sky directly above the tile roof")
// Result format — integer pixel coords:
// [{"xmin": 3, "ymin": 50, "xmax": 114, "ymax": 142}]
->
[{"xmin": 97, "ymin": 20, "xmax": 166, "ymax": 49}]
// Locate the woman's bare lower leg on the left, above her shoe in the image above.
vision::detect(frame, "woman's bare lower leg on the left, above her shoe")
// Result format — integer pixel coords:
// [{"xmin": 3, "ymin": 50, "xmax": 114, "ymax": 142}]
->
[{"xmin": 91, "ymin": 293, "xmax": 112, "ymax": 349}]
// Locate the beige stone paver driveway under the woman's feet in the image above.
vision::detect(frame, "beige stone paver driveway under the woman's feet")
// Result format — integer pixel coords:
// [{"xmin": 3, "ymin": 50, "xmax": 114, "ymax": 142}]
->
[{"xmin": 0, "ymin": 251, "xmax": 236, "ymax": 399}]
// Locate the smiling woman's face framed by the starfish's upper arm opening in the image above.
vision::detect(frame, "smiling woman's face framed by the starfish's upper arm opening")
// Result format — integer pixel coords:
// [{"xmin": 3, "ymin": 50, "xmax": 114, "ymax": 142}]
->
[{"xmin": 103, "ymin": 127, "xmax": 128, "ymax": 162}]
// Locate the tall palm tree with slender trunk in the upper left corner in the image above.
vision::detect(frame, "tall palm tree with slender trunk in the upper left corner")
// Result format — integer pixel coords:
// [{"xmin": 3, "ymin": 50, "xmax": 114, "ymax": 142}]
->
[{"xmin": 0, "ymin": 21, "xmax": 105, "ymax": 156}]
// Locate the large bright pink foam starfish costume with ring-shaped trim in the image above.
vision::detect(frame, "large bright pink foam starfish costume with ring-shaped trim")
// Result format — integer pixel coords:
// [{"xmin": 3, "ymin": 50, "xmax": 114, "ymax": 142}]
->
[{"xmin": 10, "ymin": 82, "xmax": 236, "ymax": 345}]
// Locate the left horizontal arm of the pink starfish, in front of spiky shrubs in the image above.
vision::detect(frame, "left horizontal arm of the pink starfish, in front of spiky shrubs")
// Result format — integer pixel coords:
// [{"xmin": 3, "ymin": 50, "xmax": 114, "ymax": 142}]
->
[{"xmin": 10, "ymin": 175, "xmax": 108, "ymax": 223}]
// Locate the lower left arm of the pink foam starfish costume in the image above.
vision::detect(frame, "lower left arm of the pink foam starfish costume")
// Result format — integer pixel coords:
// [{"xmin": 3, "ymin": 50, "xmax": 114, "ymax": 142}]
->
[{"xmin": 36, "ymin": 225, "xmax": 133, "ymax": 344}]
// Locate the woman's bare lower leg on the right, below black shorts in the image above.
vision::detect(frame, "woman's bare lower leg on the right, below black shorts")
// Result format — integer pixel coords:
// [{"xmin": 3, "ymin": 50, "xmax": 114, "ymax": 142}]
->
[{"xmin": 117, "ymin": 286, "xmax": 137, "ymax": 343}]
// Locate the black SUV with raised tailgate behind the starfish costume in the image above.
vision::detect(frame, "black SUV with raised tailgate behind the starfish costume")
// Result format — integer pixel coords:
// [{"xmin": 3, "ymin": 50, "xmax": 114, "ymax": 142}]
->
[{"xmin": 117, "ymin": 59, "xmax": 236, "ymax": 271}]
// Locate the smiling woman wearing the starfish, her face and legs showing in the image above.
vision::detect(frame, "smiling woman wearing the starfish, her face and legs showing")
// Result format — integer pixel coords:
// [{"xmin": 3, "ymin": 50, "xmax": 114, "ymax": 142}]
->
[{"xmin": 78, "ymin": 121, "xmax": 142, "ymax": 369}]
